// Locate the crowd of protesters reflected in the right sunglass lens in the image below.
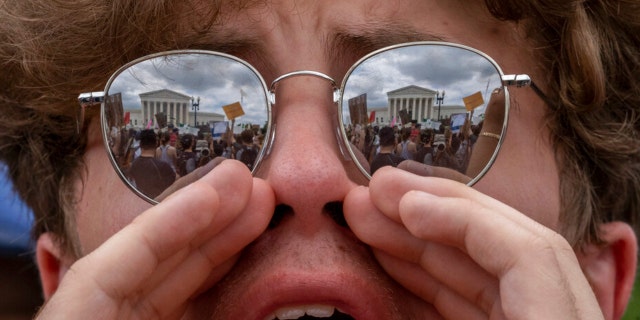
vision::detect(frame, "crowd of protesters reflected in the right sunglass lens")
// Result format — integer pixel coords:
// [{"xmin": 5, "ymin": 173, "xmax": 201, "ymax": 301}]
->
[{"xmin": 347, "ymin": 121, "xmax": 482, "ymax": 174}]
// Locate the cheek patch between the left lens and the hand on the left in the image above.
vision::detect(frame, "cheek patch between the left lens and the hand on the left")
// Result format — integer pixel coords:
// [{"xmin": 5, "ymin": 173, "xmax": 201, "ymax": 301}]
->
[{"xmin": 75, "ymin": 144, "xmax": 151, "ymax": 254}]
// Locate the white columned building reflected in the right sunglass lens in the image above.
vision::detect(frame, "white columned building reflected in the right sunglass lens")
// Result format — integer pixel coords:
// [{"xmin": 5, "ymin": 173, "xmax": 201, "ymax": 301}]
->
[{"xmin": 368, "ymin": 85, "xmax": 467, "ymax": 125}]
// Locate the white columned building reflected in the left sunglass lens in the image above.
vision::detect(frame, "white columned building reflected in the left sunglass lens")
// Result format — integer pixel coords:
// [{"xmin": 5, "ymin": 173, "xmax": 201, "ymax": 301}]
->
[{"xmin": 125, "ymin": 89, "xmax": 224, "ymax": 127}]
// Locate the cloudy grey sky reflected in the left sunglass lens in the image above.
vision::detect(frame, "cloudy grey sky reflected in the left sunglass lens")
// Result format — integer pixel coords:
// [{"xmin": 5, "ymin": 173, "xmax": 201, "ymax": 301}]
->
[{"xmin": 108, "ymin": 53, "xmax": 267, "ymax": 125}]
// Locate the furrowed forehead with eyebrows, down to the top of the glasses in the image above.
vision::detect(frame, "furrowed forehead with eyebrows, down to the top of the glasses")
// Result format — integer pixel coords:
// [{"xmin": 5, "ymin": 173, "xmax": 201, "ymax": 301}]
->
[{"xmin": 178, "ymin": 0, "xmax": 531, "ymax": 83}]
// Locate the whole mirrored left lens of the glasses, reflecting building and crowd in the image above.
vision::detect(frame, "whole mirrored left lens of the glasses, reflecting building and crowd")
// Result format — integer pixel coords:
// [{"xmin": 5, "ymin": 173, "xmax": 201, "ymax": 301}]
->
[{"xmin": 102, "ymin": 51, "xmax": 270, "ymax": 202}]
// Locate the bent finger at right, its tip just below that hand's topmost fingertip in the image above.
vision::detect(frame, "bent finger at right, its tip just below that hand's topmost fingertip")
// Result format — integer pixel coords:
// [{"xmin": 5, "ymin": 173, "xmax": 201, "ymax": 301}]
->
[{"xmin": 400, "ymin": 191, "xmax": 597, "ymax": 319}]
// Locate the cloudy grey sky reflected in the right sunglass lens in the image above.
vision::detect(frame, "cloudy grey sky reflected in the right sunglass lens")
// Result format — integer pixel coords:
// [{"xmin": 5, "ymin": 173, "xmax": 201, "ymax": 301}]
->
[{"xmin": 343, "ymin": 46, "xmax": 501, "ymax": 120}]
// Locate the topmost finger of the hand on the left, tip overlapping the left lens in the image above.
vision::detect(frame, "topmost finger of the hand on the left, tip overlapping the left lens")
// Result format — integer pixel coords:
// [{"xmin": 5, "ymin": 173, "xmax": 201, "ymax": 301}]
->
[{"xmin": 81, "ymin": 163, "xmax": 252, "ymax": 300}]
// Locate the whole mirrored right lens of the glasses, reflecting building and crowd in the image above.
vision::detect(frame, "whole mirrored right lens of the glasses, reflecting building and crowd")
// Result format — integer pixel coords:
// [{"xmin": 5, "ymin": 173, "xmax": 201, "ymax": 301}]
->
[{"xmin": 340, "ymin": 43, "xmax": 509, "ymax": 184}]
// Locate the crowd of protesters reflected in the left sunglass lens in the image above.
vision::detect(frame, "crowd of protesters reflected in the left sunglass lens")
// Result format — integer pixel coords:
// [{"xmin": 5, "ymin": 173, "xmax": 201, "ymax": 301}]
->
[{"xmin": 109, "ymin": 127, "xmax": 263, "ymax": 198}]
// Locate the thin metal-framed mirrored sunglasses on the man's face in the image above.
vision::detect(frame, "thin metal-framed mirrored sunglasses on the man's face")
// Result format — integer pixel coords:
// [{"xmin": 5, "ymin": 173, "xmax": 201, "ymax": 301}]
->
[{"xmin": 78, "ymin": 42, "xmax": 546, "ymax": 203}]
